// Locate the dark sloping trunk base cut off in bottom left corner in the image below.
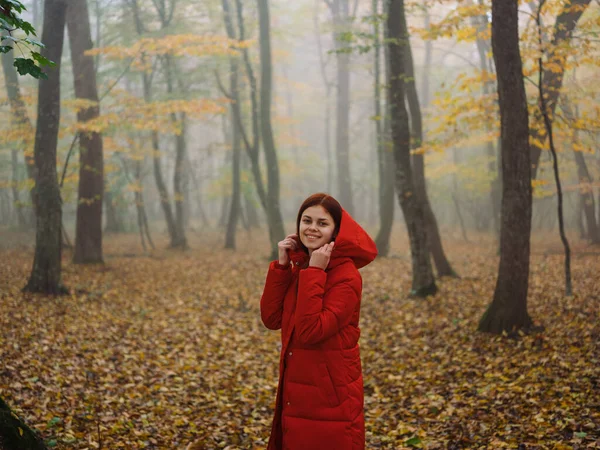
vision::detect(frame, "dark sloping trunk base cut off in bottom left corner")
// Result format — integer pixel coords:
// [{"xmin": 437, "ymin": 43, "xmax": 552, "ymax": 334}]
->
[{"xmin": 0, "ymin": 398, "xmax": 47, "ymax": 450}]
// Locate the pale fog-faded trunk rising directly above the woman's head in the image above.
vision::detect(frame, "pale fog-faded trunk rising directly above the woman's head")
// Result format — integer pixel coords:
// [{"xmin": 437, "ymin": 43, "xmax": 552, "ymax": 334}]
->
[{"xmin": 329, "ymin": 0, "xmax": 354, "ymax": 215}]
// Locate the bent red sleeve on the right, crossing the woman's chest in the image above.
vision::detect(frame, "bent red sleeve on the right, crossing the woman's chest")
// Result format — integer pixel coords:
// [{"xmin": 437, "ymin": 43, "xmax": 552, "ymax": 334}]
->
[{"xmin": 296, "ymin": 267, "xmax": 362, "ymax": 345}]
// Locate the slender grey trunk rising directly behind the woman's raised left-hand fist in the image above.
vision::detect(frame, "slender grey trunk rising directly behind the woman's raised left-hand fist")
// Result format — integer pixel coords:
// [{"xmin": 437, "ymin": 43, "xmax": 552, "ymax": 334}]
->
[{"xmin": 258, "ymin": 0, "xmax": 285, "ymax": 259}]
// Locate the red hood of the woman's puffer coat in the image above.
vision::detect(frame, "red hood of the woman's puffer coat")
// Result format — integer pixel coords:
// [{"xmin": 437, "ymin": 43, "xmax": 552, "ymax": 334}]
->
[{"xmin": 290, "ymin": 209, "xmax": 377, "ymax": 269}]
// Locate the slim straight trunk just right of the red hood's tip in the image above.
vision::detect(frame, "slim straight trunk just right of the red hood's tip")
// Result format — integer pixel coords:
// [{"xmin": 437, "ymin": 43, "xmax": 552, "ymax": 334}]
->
[{"xmin": 373, "ymin": 0, "xmax": 394, "ymax": 257}]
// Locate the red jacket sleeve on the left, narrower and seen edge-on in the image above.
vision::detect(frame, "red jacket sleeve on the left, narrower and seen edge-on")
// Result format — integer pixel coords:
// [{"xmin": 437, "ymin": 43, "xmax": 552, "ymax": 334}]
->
[{"xmin": 260, "ymin": 261, "xmax": 292, "ymax": 330}]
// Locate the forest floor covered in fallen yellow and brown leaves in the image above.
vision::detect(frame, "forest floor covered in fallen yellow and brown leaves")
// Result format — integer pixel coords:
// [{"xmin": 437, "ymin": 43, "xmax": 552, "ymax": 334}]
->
[{"xmin": 0, "ymin": 232, "xmax": 600, "ymax": 449}]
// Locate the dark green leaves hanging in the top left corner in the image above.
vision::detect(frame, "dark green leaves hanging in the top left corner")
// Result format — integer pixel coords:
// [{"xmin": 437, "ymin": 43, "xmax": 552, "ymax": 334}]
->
[{"xmin": 0, "ymin": 0, "xmax": 55, "ymax": 79}]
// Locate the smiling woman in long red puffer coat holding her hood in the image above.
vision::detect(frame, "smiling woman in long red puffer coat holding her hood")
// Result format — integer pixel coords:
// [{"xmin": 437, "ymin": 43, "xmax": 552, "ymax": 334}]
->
[{"xmin": 260, "ymin": 193, "xmax": 377, "ymax": 450}]
